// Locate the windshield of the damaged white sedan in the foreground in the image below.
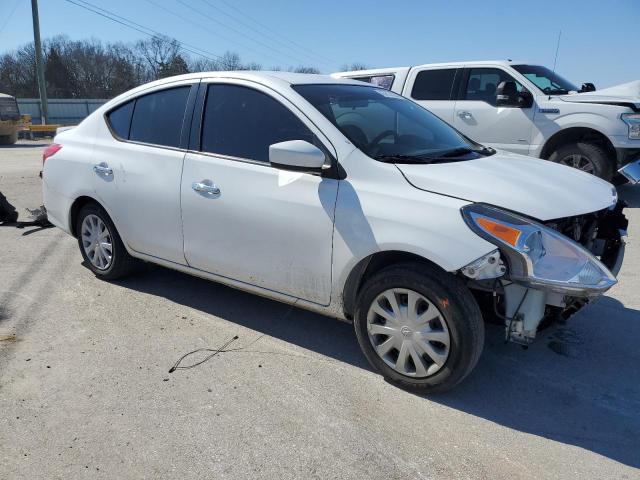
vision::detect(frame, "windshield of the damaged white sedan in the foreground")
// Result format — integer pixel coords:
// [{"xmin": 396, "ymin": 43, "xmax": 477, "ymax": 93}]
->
[{"xmin": 293, "ymin": 84, "xmax": 488, "ymax": 163}]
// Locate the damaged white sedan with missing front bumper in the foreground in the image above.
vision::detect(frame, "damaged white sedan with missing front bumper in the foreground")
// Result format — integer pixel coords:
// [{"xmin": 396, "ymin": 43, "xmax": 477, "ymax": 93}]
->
[{"xmin": 43, "ymin": 72, "xmax": 627, "ymax": 391}]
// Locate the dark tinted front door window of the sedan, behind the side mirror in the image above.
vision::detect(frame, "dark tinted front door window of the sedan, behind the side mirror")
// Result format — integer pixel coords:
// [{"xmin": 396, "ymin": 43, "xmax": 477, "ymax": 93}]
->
[{"xmin": 202, "ymin": 85, "xmax": 314, "ymax": 162}]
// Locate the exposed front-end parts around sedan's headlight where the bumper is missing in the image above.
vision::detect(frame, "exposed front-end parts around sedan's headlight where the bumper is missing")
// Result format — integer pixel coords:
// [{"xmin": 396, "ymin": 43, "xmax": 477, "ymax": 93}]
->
[{"xmin": 461, "ymin": 201, "xmax": 628, "ymax": 345}]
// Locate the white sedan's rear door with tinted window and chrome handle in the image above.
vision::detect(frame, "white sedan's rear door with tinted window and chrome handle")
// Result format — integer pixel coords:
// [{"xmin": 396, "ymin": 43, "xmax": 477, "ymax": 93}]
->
[{"xmin": 93, "ymin": 84, "xmax": 196, "ymax": 265}]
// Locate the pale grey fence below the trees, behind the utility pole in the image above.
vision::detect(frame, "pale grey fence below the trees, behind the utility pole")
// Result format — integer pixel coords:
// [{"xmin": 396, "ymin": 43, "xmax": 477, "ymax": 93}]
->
[{"xmin": 16, "ymin": 98, "xmax": 107, "ymax": 125}]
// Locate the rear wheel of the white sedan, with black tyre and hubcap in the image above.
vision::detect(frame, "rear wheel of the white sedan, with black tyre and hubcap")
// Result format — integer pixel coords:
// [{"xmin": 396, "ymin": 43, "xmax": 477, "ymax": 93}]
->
[{"xmin": 76, "ymin": 203, "xmax": 137, "ymax": 280}]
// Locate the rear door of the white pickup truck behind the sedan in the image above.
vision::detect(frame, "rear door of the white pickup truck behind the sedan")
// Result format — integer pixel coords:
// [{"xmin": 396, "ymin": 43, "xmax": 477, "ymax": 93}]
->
[{"xmin": 403, "ymin": 67, "xmax": 462, "ymax": 125}]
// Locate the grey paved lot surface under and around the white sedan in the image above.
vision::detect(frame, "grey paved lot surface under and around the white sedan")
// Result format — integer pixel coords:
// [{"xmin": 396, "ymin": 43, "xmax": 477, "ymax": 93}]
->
[{"xmin": 0, "ymin": 142, "xmax": 640, "ymax": 479}]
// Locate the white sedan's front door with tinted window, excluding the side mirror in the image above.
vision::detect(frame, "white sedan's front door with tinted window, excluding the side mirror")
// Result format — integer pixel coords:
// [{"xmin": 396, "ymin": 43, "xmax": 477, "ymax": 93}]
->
[{"xmin": 182, "ymin": 80, "xmax": 338, "ymax": 305}]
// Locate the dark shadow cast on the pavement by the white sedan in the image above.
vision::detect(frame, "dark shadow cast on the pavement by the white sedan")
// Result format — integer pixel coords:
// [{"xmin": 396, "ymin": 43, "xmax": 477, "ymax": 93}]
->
[{"xmin": 118, "ymin": 266, "xmax": 640, "ymax": 467}]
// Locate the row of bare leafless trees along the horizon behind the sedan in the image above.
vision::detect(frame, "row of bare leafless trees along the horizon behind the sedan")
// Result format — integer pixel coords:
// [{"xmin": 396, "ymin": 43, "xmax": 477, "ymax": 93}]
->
[{"xmin": 0, "ymin": 35, "xmax": 319, "ymax": 98}]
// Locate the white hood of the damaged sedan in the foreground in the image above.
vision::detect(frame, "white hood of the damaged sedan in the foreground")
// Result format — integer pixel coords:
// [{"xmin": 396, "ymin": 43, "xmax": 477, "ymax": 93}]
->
[{"xmin": 397, "ymin": 151, "xmax": 616, "ymax": 221}]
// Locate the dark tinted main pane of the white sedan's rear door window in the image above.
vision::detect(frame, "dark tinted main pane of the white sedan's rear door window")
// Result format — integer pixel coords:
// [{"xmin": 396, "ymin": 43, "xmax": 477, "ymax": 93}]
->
[{"xmin": 129, "ymin": 87, "xmax": 190, "ymax": 147}]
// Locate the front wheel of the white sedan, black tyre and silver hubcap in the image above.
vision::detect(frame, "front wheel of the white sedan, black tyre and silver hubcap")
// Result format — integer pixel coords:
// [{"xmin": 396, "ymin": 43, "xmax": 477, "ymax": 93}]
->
[{"xmin": 354, "ymin": 263, "xmax": 484, "ymax": 393}]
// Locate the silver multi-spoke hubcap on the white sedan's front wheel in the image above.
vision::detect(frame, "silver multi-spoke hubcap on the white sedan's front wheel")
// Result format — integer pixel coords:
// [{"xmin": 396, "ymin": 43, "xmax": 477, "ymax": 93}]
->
[{"xmin": 367, "ymin": 288, "xmax": 451, "ymax": 378}]
